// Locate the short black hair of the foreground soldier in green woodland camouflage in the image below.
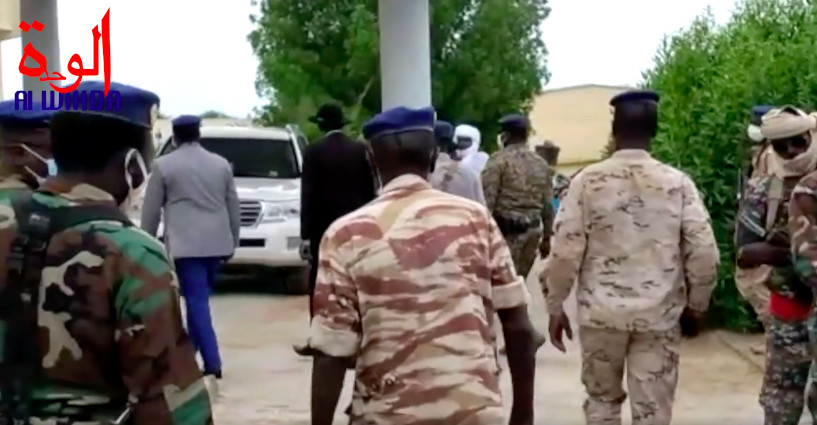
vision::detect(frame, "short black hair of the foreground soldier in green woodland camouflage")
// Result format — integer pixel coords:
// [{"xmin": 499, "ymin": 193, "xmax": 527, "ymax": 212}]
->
[{"xmin": 50, "ymin": 111, "xmax": 151, "ymax": 172}]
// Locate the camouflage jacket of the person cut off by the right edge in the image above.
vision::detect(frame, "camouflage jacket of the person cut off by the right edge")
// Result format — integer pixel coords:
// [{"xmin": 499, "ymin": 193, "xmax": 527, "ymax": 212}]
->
[{"xmin": 789, "ymin": 171, "xmax": 817, "ymax": 292}]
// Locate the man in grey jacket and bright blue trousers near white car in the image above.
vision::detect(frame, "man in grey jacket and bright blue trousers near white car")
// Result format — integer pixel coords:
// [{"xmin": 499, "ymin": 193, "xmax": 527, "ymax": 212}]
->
[{"xmin": 142, "ymin": 115, "xmax": 236, "ymax": 379}]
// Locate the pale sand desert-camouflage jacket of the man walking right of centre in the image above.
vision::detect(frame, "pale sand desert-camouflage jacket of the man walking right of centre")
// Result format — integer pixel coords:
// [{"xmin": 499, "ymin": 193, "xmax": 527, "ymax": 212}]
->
[{"xmin": 540, "ymin": 150, "xmax": 719, "ymax": 332}]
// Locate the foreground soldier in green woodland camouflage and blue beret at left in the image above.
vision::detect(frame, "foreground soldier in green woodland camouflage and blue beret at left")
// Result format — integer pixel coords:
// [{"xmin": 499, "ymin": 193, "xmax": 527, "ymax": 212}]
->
[{"xmin": 0, "ymin": 83, "xmax": 212, "ymax": 425}]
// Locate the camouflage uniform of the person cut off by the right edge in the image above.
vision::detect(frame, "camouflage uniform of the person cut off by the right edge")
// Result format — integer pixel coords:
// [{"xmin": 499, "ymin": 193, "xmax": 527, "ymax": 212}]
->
[{"xmin": 789, "ymin": 172, "xmax": 817, "ymax": 422}]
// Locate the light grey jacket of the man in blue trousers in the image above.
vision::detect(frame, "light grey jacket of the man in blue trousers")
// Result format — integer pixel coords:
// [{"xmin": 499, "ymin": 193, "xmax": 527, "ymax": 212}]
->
[{"xmin": 142, "ymin": 143, "xmax": 241, "ymax": 258}]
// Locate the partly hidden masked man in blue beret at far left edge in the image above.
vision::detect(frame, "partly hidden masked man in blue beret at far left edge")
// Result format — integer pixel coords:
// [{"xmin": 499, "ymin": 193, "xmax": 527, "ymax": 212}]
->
[{"xmin": 0, "ymin": 100, "xmax": 56, "ymax": 200}]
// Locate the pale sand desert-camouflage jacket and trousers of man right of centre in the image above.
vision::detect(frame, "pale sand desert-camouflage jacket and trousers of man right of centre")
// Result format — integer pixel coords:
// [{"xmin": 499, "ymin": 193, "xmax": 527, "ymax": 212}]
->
[{"xmin": 540, "ymin": 150, "xmax": 718, "ymax": 425}]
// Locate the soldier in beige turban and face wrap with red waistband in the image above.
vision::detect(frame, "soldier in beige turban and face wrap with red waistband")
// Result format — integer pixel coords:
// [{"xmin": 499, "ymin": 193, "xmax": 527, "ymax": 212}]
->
[{"xmin": 736, "ymin": 107, "xmax": 817, "ymax": 425}]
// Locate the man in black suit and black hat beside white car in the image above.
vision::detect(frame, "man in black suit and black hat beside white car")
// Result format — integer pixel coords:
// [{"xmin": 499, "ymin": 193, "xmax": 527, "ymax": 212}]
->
[{"xmin": 294, "ymin": 103, "xmax": 376, "ymax": 356}]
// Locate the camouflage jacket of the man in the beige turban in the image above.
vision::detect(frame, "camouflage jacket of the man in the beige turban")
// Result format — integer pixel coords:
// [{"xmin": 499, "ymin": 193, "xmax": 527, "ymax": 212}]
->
[{"xmin": 735, "ymin": 175, "xmax": 812, "ymax": 305}]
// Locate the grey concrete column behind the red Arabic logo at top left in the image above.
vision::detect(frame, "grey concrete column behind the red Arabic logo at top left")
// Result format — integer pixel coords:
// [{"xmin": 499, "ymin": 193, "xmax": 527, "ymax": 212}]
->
[{"xmin": 20, "ymin": 0, "xmax": 59, "ymax": 97}]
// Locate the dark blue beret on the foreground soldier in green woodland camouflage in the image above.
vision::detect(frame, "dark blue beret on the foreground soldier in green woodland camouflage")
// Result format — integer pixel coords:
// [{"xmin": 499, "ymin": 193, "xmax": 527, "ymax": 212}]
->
[{"xmin": 64, "ymin": 81, "xmax": 159, "ymax": 128}]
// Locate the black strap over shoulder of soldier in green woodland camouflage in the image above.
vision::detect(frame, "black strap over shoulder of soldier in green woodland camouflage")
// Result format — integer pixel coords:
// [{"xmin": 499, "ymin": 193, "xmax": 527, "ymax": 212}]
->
[{"xmin": 0, "ymin": 192, "xmax": 133, "ymax": 424}]
